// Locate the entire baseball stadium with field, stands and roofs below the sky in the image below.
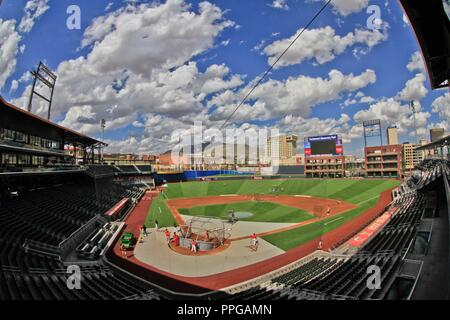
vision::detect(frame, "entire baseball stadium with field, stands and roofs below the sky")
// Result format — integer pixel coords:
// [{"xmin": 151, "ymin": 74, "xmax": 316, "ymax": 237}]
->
[{"xmin": 0, "ymin": 0, "xmax": 450, "ymax": 301}]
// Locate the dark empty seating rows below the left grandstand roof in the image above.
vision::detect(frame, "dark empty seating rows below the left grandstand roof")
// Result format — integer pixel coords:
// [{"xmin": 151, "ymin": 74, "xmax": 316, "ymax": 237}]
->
[{"xmin": 0, "ymin": 173, "xmax": 159, "ymax": 300}]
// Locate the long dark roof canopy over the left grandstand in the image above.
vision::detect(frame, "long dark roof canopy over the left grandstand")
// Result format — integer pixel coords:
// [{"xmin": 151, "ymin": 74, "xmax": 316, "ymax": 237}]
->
[{"xmin": 0, "ymin": 96, "xmax": 106, "ymax": 146}]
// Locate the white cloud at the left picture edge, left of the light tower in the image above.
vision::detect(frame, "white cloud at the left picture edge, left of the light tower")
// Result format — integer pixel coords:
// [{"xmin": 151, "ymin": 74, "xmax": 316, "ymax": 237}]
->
[{"xmin": 0, "ymin": 19, "xmax": 21, "ymax": 90}]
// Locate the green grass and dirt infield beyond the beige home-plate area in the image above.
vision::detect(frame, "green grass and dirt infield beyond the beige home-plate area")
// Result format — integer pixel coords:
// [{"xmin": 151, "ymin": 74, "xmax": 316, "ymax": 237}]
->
[{"xmin": 146, "ymin": 179, "xmax": 399, "ymax": 250}]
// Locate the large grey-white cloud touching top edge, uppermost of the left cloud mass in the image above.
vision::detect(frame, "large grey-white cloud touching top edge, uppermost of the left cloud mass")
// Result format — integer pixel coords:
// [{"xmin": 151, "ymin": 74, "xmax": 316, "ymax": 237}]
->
[{"xmin": 82, "ymin": 0, "xmax": 234, "ymax": 76}]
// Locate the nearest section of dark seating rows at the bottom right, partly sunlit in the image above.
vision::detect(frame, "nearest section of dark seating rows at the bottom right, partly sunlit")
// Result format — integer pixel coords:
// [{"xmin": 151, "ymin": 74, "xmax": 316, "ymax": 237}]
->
[{"xmin": 230, "ymin": 255, "xmax": 401, "ymax": 300}]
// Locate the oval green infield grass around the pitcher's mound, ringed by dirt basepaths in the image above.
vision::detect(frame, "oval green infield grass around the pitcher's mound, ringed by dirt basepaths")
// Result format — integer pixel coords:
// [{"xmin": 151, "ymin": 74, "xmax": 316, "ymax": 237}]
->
[{"xmin": 178, "ymin": 201, "xmax": 313, "ymax": 223}]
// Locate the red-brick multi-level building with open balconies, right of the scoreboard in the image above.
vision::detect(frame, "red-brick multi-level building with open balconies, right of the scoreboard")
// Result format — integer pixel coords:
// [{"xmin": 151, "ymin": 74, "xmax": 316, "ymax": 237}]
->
[{"xmin": 364, "ymin": 144, "xmax": 403, "ymax": 178}]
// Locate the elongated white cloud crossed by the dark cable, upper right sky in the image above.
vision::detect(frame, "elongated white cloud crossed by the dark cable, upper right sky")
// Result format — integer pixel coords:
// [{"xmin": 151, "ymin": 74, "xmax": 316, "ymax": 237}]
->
[{"xmin": 264, "ymin": 26, "xmax": 388, "ymax": 68}]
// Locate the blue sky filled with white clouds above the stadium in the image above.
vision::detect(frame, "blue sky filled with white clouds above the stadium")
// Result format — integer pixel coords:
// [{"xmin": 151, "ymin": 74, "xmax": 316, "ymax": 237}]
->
[{"xmin": 0, "ymin": 0, "xmax": 450, "ymax": 155}]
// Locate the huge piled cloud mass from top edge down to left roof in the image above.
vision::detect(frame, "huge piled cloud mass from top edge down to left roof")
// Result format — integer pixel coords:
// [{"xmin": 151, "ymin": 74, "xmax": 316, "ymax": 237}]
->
[{"xmin": 10, "ymin": 0, "xmax": 243, "ymax": 145}]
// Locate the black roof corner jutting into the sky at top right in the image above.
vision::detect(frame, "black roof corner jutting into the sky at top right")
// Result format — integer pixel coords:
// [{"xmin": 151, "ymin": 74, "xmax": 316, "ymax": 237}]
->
[{"xmin": 399, "ymin": 0, "xmax": 450, "ymax": 89}]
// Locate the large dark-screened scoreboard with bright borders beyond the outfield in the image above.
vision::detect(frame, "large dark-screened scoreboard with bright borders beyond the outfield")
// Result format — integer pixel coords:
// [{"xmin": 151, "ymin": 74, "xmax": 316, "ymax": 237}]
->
[{"xmin": 304, "ymin": 135, "xmax": 344, "ymax": 157}]
